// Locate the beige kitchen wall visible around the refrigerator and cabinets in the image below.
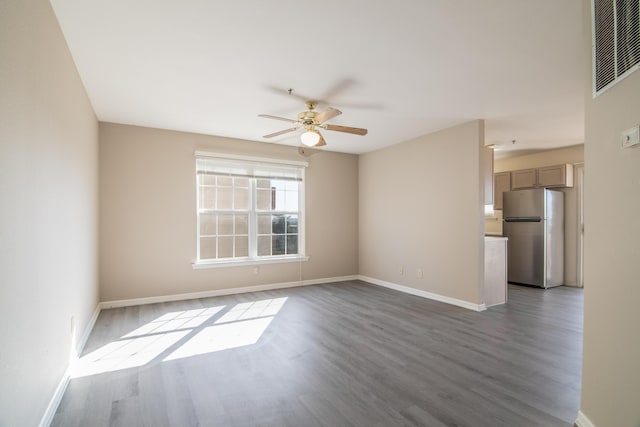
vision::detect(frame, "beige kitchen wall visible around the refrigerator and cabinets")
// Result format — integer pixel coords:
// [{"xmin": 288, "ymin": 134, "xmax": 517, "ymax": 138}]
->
[{"xmin": 487, "ymin": 144, "xmax": 584, "ymax": 286}]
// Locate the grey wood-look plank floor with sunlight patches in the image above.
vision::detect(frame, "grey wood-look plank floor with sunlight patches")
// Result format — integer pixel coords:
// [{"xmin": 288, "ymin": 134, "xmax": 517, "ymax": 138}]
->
[{"xmin": 52, "ymin": 281, "xmax": 583, "ymax": 427}]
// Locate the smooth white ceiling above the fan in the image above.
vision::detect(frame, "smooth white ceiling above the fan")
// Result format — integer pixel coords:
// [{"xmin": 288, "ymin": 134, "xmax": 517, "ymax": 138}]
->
[{"xmin": 51, "ymin": 0, "xmax": 585, "ymax": 154}]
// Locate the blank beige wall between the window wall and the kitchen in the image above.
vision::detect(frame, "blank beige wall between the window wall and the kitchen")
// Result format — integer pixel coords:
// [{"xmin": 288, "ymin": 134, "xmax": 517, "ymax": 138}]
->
[{"xmin": 360, "ymin": 121, "xmax": 484, "ymax": 304}]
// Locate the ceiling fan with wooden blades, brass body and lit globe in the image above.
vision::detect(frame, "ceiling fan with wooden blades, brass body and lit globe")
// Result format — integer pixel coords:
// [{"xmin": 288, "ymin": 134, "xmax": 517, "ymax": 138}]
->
[{"xmin": 258, "ymin": 101, "xmax": 367, "ymax": 147}]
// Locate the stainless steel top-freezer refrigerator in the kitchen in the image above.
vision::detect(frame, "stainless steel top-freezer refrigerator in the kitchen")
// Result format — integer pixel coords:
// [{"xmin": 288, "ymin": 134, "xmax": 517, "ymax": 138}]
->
[{"xmin": 503, "ymin": 188, "xmax": 564, "ymax": 288}]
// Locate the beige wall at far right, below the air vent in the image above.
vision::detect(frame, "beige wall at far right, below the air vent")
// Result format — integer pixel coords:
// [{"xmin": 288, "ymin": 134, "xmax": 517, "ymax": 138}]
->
[{"xmin": 581, "ymin": 0, "xmax": 640, "ymax": 427}]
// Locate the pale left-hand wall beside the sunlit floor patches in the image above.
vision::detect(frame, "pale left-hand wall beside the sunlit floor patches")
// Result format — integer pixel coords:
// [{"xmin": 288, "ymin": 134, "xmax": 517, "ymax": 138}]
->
[{"xmin": 0, "ymin": 0, "xmax": 98, "ymax": 427}]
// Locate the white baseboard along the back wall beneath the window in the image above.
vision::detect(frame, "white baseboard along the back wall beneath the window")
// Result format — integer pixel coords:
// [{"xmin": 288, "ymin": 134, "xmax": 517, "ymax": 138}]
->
[{"xmin": 99, "ymin": 276, "xmax": 358, "ymax": 309}]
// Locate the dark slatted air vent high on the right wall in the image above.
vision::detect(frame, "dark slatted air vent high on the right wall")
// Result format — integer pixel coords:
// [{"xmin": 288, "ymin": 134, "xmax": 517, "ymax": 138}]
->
[{"xmin": 593, "ymin": 0, "xmax": 640, "ymax": 95}]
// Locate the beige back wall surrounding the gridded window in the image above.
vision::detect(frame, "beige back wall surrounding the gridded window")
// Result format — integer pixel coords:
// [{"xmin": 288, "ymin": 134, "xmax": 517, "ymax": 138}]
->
[{"xmin": 100, "ymin": 123, "xmax": 358, "ymax": 301}]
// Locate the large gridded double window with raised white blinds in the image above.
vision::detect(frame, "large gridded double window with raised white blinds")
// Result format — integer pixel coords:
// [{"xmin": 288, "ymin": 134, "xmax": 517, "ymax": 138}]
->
[{"xmin": 196, "ymin": 152, "xmax": 306, "ymax": 265}]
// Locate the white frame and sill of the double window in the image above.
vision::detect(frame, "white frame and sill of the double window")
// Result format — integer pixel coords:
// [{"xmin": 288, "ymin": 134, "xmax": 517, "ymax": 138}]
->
[{"xmin": 192, "ymin": 151, "xmax": 309, "ymax": 269}]
